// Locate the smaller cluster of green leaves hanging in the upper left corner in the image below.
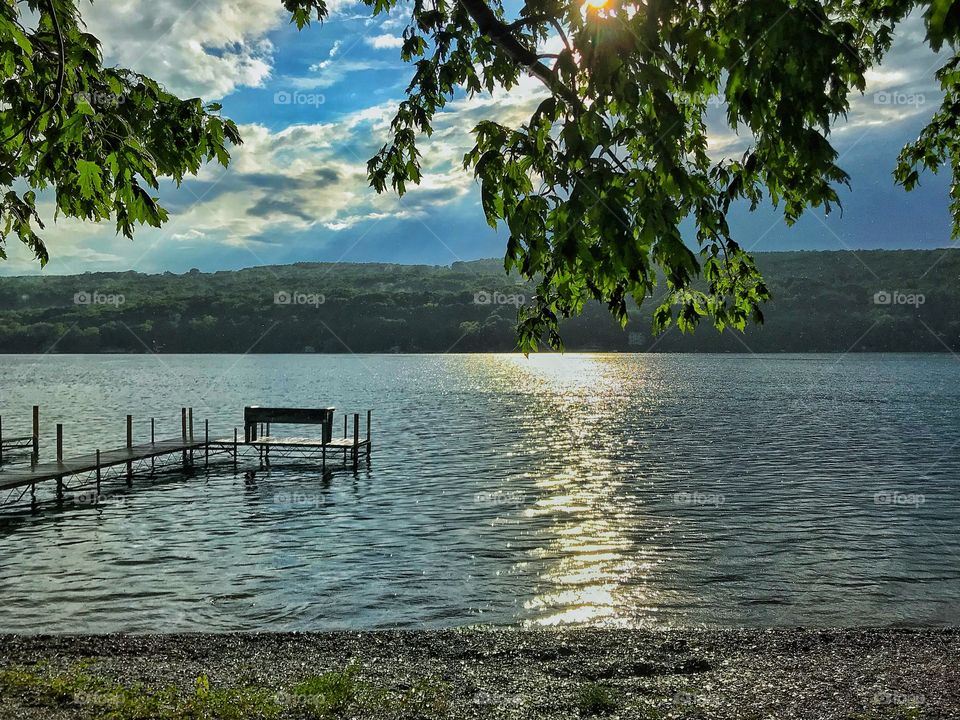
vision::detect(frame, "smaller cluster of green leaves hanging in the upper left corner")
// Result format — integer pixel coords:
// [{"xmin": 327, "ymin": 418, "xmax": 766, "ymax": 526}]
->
[{"xmin": 0, "ymin": 0, "xmax": 240, "ymax": 264}]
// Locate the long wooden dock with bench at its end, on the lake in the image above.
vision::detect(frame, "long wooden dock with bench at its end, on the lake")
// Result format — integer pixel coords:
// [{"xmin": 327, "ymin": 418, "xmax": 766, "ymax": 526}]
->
[{"xmin": 0, "ymin": 406, "xmax": 372, "ymax": 509}]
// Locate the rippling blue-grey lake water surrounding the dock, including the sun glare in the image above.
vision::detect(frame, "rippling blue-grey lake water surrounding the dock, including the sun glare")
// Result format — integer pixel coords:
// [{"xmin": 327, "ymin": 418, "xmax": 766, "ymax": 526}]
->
[{"xmin": 0, "ymin": 355, "xmax": 960, "ymax": 632}]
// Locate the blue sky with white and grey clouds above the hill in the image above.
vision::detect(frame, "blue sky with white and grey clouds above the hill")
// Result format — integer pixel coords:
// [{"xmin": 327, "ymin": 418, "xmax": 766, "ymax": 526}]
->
[{"xmin": 0, "ymin": 0, "xmax": 950, "ymax": 275}]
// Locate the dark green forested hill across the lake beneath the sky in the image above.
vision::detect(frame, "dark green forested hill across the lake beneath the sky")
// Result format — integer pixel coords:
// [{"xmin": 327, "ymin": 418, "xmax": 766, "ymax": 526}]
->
[{"xmin": 0, "ymin": 250, "xmax": 960, "ymax": 353}]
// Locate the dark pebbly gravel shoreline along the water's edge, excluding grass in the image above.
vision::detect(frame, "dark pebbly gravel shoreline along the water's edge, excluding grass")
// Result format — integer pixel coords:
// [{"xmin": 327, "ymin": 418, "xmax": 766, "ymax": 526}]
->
[{"xmin": 0, "ymin": 628, "xmax": 960, "ymax": 720}]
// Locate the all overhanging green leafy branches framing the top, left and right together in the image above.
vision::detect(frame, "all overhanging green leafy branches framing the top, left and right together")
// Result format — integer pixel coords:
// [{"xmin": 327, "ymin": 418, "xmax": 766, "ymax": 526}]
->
[{"xmin": 0, "ymin": 0, "xmax": 960, "ymax": 351}]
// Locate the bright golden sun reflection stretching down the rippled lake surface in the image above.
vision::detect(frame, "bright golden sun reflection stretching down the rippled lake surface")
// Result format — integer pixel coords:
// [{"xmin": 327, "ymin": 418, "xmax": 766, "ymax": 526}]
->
[{"xmin": 488, "ymin": 355, "xmax": 652, "ymax": 626}]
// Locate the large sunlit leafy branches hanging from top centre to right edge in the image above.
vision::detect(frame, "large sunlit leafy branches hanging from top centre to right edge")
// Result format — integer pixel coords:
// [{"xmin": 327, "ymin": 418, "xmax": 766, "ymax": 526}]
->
[{"xmin": 285, "ymin": 0, "xmax": 960, "ymax": 351}]
